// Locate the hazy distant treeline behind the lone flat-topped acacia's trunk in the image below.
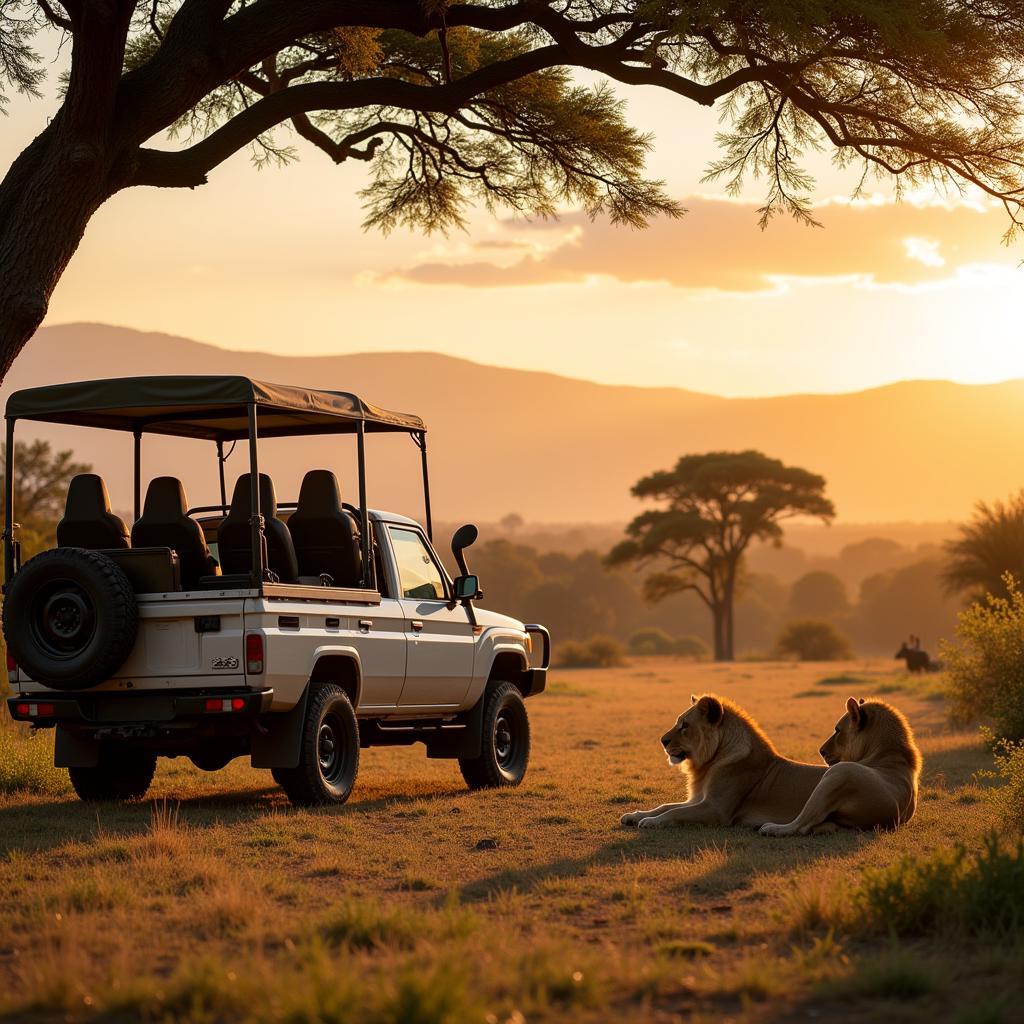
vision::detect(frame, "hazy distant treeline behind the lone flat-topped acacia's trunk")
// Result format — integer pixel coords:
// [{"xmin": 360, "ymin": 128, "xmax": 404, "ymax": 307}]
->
[{"xmin": 470, "ymin": 539, "xmax": 964, "ymax": 655}]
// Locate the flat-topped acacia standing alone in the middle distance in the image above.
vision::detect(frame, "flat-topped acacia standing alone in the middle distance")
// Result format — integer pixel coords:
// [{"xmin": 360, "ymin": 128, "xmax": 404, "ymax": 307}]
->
[{"xmin": 607, "ymin": 452, "xmax": 836, "ymax": 662}]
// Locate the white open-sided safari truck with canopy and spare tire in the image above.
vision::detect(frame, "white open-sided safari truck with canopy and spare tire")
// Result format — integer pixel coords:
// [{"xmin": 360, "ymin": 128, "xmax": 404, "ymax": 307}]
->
[{"xmin": 3, "ymin": 376, "xmax": 550, "ymax": 805}]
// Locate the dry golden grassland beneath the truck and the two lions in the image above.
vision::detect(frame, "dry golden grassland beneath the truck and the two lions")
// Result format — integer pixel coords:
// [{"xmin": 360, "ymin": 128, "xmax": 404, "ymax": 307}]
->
[{"xmin": 0, "ymin": 658, "xmax": 1011, "ymax": 1024}]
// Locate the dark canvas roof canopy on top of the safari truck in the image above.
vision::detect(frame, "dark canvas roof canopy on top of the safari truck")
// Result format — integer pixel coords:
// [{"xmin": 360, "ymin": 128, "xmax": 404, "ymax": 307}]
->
[{"xmin": 7, "ymin": 375, "xmax": 426, "ymax": 440}]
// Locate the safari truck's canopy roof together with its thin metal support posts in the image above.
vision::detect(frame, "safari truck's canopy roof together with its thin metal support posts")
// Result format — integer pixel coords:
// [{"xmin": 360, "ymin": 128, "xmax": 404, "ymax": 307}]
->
[{"xmin": 3, "ymin": 376, "xmax": 433, "ymax": 590}]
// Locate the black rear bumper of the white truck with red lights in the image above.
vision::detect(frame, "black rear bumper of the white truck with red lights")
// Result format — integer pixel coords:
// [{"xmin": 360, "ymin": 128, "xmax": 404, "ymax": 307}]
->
[{"xmin": 7, "ymin": 689, "xmax": 273, "ymax": 729}]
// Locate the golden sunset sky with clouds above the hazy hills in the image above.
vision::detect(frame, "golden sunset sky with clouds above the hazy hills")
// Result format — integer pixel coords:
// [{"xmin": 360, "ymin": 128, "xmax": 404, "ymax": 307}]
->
[{"xmin": 0, "ymin": 44, "xmax": 1024, "ymax": 395}]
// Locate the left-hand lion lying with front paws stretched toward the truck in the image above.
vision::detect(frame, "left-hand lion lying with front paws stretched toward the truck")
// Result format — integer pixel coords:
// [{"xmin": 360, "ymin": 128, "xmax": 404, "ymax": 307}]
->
[{"xmin": 621, "ymin": 693, "xmax": 826, "ymax": 828}]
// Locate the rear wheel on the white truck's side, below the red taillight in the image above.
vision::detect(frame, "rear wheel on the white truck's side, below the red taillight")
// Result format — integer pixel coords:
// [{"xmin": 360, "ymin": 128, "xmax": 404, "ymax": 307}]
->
[{"xmin": 272, "ymin": 684, "xmax": 359, "ymax": 807}]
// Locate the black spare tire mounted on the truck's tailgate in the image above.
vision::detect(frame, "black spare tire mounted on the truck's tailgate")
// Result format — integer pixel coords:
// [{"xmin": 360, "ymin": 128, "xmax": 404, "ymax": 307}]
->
[{"xmin": 3, "ymin": 548, "xmax": 138, "ymax": 690}]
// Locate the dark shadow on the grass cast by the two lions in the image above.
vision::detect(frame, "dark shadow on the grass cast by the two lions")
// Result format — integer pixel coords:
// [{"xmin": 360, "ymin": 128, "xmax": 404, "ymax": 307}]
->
[{"xmin": 462, "ymin": 825, "xmax": 878, "ymax": 901}]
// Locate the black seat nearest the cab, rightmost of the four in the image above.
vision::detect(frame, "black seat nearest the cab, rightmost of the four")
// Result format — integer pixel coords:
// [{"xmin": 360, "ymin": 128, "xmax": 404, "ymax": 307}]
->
[{"xmin": 288, "ymin": 469, "xmax": 362, "ymax": 587}]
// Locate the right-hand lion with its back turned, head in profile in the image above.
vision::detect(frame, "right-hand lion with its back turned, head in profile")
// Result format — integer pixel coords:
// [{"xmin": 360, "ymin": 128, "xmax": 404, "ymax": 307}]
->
[{"xmin": 761, "ymin": 697, "xmax": 921, "ymax": 836}]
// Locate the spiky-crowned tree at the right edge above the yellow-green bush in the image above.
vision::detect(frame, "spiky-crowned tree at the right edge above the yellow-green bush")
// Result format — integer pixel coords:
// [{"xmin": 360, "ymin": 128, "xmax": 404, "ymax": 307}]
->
[{"xmin": 942, "ymin": 490, "xmax": 1024, "ymax": 597}]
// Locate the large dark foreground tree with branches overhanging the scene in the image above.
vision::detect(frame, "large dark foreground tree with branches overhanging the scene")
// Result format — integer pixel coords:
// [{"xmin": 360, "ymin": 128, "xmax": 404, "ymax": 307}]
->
[{"xmin": 0, "ymin": 0, "xmax": 1024, "ymax": 377}]
